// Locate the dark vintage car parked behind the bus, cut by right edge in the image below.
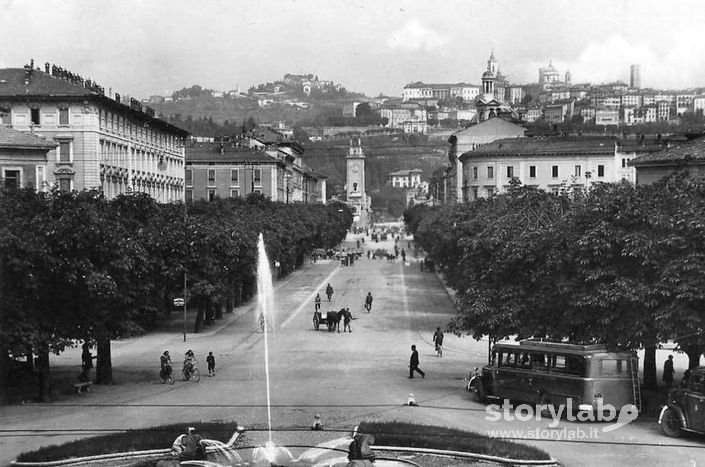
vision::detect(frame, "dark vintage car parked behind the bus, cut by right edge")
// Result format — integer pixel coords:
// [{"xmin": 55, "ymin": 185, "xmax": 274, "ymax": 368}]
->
[{"xmin": 658, "ymin": 366, "xmax": 705, "ymax": 437}]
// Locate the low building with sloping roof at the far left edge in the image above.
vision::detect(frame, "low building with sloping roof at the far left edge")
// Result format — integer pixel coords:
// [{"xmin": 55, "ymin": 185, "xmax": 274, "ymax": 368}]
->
[{"xmin": 0, "ymin": 125, "xmax": 57, "ymax": 191}]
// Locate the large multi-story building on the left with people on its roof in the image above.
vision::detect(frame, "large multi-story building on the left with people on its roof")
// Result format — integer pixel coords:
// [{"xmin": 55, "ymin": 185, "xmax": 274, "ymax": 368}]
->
[{"xmin": 0, "ymin": 63, "xmax": 188, "ymax": 202}]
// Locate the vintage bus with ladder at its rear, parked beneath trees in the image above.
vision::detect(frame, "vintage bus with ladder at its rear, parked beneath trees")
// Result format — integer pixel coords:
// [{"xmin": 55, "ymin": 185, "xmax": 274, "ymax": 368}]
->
[{"xmin": 466, "ymin": 339, "xmax": 641, "ymax": 412}]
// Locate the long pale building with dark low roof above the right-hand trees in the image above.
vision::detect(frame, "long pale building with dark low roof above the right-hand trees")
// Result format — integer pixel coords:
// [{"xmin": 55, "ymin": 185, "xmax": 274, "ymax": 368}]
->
[{"xmin": 460, "ymin": 138, "xmax": 659, "ymax": 201}]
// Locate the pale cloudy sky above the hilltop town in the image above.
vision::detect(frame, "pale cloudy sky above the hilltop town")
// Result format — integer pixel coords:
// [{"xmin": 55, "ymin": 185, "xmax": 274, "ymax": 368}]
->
[{"xmin": 0, "ymin": 0, "xmax": 705, "ymax": 97}]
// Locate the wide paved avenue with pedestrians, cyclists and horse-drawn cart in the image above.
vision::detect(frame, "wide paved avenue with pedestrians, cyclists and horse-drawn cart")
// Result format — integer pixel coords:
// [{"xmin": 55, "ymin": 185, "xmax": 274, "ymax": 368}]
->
[{"xmin": 0, "ymin": 236, "xmax": 705, "ymax": 466}]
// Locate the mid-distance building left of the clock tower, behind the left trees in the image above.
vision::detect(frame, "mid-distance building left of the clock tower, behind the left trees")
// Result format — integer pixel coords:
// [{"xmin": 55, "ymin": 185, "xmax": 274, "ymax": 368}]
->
[{"xmin": 186, "ymin": 137, "xmax": 326, "ymax": 203}]
